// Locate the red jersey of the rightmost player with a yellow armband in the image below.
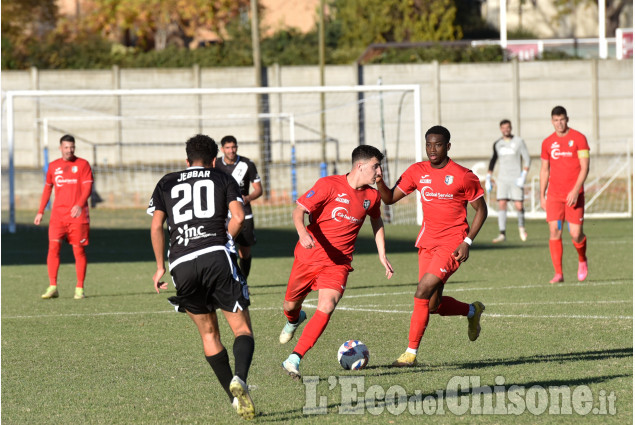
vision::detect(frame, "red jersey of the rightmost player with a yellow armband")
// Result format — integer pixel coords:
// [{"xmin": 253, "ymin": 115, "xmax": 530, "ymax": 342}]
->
[{"xmin": 540, "ymin": 128, "xmax": 589, "ymax": 196}]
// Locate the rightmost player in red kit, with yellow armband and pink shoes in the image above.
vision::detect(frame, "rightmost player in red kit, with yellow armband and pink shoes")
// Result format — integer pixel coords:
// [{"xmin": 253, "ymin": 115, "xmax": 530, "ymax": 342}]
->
[{"xmin": 540, "ymin": 106, "xmax": 590, "ymax": 283}]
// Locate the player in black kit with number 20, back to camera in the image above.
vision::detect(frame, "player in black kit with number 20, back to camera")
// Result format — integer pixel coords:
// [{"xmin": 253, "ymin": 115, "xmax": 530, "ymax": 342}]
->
[{"xmin": 148, "ymin": 134, "xmax": 255, "ymax": 419}]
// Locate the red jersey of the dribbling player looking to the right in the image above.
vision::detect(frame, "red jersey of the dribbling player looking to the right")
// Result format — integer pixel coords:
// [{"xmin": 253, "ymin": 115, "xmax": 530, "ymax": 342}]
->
[{"xmin": 295, "ymin": 175, "xmax": 381, "ymax": 265}]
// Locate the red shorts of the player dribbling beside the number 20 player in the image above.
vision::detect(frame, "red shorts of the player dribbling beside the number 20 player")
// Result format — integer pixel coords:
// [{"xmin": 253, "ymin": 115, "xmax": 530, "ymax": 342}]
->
[{"xmin": 284, "ymin": 260, "xmax": 353, "ymax": 301}]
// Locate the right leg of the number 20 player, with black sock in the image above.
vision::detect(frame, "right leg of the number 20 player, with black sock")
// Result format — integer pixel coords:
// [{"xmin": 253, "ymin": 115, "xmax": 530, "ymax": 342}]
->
[{"xmin": 223, "ymin": 308, "xmax": 256, "ymax": 419}]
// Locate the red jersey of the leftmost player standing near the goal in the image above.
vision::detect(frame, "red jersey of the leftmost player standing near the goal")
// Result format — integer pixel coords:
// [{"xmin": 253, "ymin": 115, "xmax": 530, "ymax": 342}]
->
[{"xmin": 39, "ymin": 157, "xmax": 93, "ymax": 223}]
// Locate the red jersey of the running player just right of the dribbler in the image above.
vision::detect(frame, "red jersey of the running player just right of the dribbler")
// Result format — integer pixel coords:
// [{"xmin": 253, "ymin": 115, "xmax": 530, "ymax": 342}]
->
[{"xmin": 397, "ymin": 159, "xmax": 483, "ymax": 248}]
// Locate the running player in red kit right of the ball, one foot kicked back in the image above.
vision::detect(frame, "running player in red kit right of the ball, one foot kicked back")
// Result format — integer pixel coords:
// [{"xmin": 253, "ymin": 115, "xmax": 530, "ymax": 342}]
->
[{"xmin": 377, "ymin": 126, "xmax": 487, "ymax": 367}]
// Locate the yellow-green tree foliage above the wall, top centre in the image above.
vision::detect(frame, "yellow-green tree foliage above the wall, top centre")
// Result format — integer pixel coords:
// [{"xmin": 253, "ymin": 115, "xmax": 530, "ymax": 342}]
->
[{"xmin": 333, "ymin": 0, "xmax": 462, "ymax": 47}]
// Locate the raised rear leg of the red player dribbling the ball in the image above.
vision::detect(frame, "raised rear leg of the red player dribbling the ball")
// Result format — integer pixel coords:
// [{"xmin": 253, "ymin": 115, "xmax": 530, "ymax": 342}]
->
[{"xmin": 279, "ymin": 261, "xmax": 320, "ymax": 344}]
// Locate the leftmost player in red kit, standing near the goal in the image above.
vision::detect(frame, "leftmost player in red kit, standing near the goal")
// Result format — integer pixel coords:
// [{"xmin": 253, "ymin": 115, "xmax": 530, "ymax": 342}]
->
[{"xmin": 33, "ymin": 134, "xmax": 93, "ymax": 300}]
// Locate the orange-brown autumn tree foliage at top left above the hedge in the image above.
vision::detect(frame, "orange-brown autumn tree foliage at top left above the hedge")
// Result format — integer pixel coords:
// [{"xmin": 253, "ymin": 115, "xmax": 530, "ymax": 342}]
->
[{"xmin": 78, "ymin": 0, "xmax": 249, "ymax": 50}]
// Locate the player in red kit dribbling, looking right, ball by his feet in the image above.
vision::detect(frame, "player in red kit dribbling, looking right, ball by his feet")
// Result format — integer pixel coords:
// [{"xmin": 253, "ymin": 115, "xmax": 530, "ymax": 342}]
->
[{"xmin": 280, "ymin": 145, "xmax": 393, "ymax": 379}]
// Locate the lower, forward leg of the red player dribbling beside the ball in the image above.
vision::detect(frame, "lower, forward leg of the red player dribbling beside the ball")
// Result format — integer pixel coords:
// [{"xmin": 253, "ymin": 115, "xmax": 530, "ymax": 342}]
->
[{"xmin": 282, "ymin": 266, "xmax": 352, "ymax": 379}]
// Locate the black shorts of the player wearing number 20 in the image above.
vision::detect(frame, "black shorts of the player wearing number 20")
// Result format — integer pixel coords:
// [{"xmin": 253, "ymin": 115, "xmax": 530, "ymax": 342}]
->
[{"xmin": 168, "ymin": 249, "xmax": 250, "ymax": 314}]
